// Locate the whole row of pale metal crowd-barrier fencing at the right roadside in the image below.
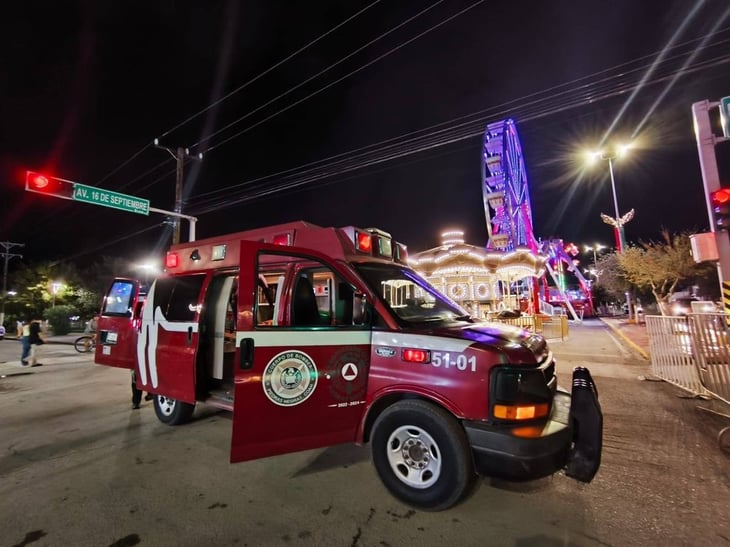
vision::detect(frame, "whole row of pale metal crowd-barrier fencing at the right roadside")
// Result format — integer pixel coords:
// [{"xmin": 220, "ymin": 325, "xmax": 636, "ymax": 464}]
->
[{"xmin": 646, "ymin": 313, "xmax": 730, "ymax": 404}]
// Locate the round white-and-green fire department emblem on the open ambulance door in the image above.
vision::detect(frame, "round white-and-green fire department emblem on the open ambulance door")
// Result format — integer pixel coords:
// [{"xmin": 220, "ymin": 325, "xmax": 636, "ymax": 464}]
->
[{"xmin": 262, "ymin": 350, "xmax": 317, "ymax": 406}]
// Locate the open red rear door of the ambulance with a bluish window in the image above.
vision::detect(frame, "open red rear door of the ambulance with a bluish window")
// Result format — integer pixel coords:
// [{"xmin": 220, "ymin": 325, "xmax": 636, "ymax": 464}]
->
[{"xmin": 94, "ymin": 278, "xmax": 144, "ymax": 369}]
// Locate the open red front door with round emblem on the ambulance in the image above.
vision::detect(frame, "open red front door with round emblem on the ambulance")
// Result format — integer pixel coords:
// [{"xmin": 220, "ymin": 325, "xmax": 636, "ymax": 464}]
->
[{"xmin": 231, "ymin": 242, "xmax": 371, "ymax": 462}]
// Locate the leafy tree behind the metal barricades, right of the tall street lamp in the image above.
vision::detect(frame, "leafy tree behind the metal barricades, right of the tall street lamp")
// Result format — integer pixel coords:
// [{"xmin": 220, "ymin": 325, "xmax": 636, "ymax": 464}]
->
[{"xmin": 617, "ymin": 229, "xmax": 711, "ymax": 315}]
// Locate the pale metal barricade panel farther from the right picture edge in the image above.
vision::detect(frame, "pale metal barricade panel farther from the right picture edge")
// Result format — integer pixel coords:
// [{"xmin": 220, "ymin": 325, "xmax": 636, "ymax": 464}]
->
[{"xmin": 646, "ymin": 315, "xmax": 707, "ymax": 395}]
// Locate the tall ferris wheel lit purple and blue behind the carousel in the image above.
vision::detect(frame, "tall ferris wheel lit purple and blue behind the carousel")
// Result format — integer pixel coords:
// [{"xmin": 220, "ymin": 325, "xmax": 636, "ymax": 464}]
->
[{"xmin": 482, "ymin": 118, "xmax": 537, "ymax": 252}]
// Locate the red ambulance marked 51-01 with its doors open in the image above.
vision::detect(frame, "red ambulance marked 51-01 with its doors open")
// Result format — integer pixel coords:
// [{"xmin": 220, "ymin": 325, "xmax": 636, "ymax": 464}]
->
[{"xmin": 95, "ymin": 222, "xmax": 603, "ymax": 510}]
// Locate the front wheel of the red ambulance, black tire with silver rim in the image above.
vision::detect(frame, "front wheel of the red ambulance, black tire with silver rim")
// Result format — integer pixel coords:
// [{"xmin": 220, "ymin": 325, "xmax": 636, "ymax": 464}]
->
[{"xmin": 371, "ymin": 400, "xmax": 476, "ymax": 511}]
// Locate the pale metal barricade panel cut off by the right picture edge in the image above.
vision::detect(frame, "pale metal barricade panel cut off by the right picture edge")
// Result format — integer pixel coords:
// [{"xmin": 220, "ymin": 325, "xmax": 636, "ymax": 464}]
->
[{"xmin": 689, "ymin": 313, "xmax": 730, "ymax": 404}]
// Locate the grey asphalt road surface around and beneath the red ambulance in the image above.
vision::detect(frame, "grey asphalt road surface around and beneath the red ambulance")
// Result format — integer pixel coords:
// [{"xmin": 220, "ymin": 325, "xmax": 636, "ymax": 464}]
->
[{"xmin": 0, "ymin": 321, "xmax": 730, "ymax": 547}]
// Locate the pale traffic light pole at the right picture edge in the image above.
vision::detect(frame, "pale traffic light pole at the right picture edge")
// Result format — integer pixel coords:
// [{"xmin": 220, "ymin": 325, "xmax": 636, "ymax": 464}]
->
[{"xmin": 692, "ymin": 100, "xmax": 730, "ymax": 314}]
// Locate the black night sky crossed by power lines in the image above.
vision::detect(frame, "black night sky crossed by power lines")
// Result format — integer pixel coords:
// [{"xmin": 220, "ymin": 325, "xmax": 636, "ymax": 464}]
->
[{"xmin": 0, "ymin": 0, "xmax": 730, "ymax": 272}]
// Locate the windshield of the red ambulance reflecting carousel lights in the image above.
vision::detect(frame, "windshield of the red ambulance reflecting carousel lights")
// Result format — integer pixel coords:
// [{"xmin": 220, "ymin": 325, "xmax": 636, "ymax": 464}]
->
[{"xmin": 356, "ymin": 263, "xmax": 469, "ymax": 323}]
